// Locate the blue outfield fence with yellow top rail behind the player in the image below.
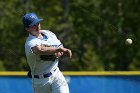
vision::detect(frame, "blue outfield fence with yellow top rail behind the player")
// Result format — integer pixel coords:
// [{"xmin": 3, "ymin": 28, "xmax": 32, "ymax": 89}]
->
[{"xmin": 0, "ymin": 71, "xmax": 140, "ymax": 93}]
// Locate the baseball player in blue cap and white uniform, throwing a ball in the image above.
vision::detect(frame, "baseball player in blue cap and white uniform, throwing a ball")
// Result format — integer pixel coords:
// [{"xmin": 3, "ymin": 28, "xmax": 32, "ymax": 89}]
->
[{"xmin": 22, "ymin": 13, "xmax": 72, "ymax": 93}]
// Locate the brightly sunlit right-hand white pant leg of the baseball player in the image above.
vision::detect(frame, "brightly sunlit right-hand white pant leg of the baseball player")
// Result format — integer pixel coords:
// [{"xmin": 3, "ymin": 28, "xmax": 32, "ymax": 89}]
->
[{"xmin": 52, "ymin": 71, "xmax": 69, "ymax": 93}]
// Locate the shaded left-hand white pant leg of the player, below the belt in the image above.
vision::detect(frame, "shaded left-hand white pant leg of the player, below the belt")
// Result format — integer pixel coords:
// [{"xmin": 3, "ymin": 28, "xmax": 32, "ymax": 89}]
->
[{"xmin": 33, "ymin": 78, "xmax": 52, "ymax": 93}]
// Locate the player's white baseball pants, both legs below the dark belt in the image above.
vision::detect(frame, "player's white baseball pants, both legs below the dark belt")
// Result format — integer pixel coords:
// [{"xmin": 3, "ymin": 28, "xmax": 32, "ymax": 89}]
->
[{"xmin": 33, "ymin": 68, "xmax": 69, "ymax": 93}]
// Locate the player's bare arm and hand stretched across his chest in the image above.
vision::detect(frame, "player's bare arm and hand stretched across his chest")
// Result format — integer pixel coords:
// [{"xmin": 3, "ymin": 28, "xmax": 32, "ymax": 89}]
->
[{"xmin": 32, "ymin": 46, "xmax": 72, "ymax": 58}]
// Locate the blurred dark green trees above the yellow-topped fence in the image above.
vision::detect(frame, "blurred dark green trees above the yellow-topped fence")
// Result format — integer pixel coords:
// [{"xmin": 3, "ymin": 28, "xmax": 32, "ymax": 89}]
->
[{"xmin": 0, "ymin": 0, "xmax": 140, "ymax": 71}]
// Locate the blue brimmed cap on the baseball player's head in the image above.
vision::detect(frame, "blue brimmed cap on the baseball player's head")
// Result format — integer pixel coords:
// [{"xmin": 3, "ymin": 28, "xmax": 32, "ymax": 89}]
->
[{"xmin": 22, "ymin": 13, "xmax": 43, "ymax": 27}]
